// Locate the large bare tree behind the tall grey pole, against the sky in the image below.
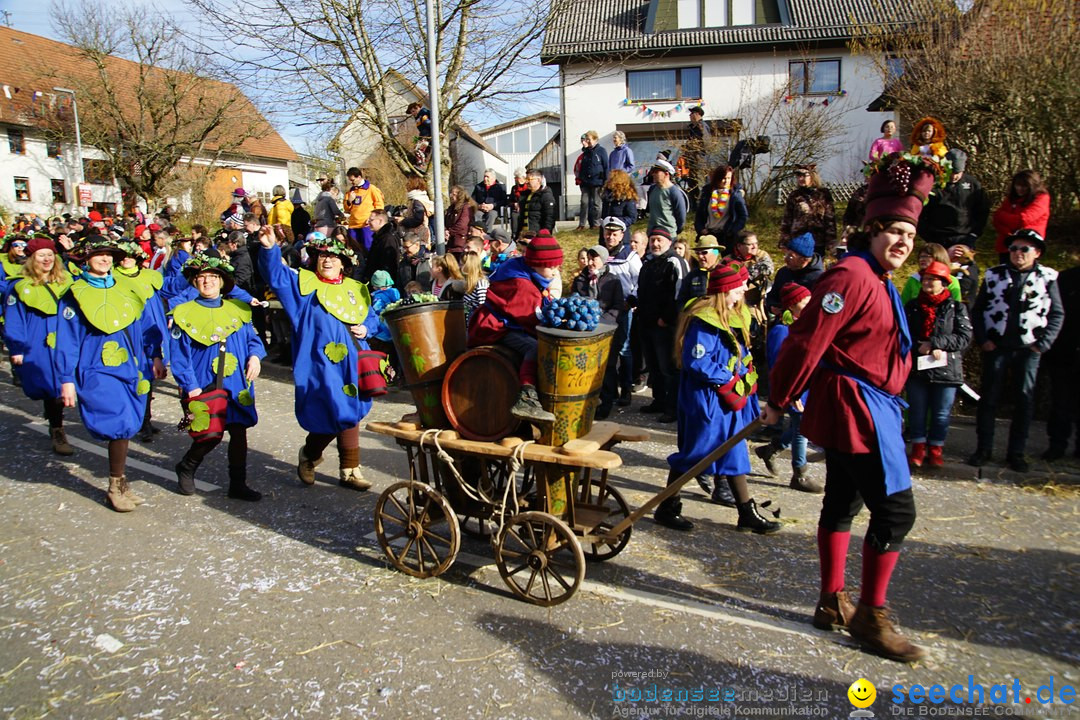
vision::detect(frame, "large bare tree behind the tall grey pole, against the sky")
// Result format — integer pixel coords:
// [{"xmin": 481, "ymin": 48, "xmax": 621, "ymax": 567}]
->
[{"xmin": 193, "ymin": 0, "xmax": 569, "ymax": 185}]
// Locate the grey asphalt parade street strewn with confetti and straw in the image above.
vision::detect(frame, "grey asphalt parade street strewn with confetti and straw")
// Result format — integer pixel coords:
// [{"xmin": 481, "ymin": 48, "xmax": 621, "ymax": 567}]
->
[{"xmin": 0, "ymin": 366, "xmax": 1080, "ymax": 719}]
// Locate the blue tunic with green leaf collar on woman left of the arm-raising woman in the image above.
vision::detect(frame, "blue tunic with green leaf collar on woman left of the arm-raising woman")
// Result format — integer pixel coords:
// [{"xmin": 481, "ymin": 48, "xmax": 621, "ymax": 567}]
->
[{"xmin": 170, "ymin": 297, "xmax": 267, "ymax": 427}]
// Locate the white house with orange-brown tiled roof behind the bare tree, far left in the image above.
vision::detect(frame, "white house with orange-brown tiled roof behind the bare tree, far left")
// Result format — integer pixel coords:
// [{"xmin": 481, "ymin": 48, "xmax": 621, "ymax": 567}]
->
[{"xmin": 0, "ymin": 27, "xmax": 298, "ymax": 216}]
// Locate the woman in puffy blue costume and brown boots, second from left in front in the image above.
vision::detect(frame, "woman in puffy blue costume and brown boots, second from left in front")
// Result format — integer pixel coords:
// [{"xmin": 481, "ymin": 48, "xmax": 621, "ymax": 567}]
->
[{"xmin": 56, "ymin": 235, "xmax": 165, "ymax": 513}]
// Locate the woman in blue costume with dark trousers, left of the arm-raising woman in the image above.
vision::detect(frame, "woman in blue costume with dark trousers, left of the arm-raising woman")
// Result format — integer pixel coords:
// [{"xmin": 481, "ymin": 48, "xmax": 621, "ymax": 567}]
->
[{"xmin": 170, "ymin": 254, "xmax": 267, "ymax": 501}]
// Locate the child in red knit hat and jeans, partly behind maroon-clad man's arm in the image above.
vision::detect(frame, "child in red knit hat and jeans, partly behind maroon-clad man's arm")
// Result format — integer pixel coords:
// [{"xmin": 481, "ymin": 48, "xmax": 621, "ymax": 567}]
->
[{"xmin": 754, "ymin": 283, "xmax": 825, "ymax": 493}]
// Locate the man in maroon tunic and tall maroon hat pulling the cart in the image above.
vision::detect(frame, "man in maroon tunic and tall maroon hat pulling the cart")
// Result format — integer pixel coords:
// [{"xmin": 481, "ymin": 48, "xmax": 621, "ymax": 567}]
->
[{"xmin": 761, "ymin": 160, "xmax": 933, "ymax": 662}]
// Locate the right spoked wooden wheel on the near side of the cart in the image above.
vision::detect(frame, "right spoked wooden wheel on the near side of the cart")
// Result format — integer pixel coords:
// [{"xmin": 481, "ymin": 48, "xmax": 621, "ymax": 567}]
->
[{"xmin": 495, "ymin": 511, "xmax": 585, "ymax": 607}]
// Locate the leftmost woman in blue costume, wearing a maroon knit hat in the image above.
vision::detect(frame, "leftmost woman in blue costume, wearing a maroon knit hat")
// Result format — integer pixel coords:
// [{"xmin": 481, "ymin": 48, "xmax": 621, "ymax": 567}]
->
[{"xmin": 4, "ymin": 237, "xmax": 75, "ymax": 456}]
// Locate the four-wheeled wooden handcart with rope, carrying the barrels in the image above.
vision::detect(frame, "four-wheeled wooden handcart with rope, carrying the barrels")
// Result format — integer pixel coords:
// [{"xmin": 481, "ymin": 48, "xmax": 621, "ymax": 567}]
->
[{"xmin": 367, "ymin": 419, "xmax": 649, "ymax": 606}]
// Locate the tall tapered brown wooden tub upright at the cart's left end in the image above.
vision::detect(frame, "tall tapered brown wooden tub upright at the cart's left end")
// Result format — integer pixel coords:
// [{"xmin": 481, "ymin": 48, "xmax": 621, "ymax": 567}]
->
[{"xmin": 382, "ymin": 302, "xmax": 465, "ymax": 427}]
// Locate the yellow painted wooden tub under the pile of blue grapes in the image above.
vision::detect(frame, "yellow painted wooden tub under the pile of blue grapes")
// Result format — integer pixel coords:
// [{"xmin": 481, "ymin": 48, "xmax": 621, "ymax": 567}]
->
[{"xmin": 537, "ymin": 325, "xmax": 616, "ymax": 446}]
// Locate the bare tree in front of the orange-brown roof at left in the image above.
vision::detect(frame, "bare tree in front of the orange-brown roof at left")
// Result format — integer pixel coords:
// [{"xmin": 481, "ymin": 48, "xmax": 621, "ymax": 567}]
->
[{"xmin": 39, "ymin": 0, "xmax": 270, "ymax": 211}]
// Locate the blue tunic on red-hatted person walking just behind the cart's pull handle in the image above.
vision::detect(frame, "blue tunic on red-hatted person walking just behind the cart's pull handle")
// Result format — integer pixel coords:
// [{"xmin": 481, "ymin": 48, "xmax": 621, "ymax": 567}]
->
[{"xmin": 667, "ymin": 313, "xmax": 758, "ymax": 475}]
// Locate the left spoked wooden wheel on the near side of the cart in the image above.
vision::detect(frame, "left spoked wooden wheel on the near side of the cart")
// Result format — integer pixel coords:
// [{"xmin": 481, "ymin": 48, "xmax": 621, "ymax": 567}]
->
[{"xmin": 375, "ymin": 480, "xmax": 461, "ymax": 578}]
